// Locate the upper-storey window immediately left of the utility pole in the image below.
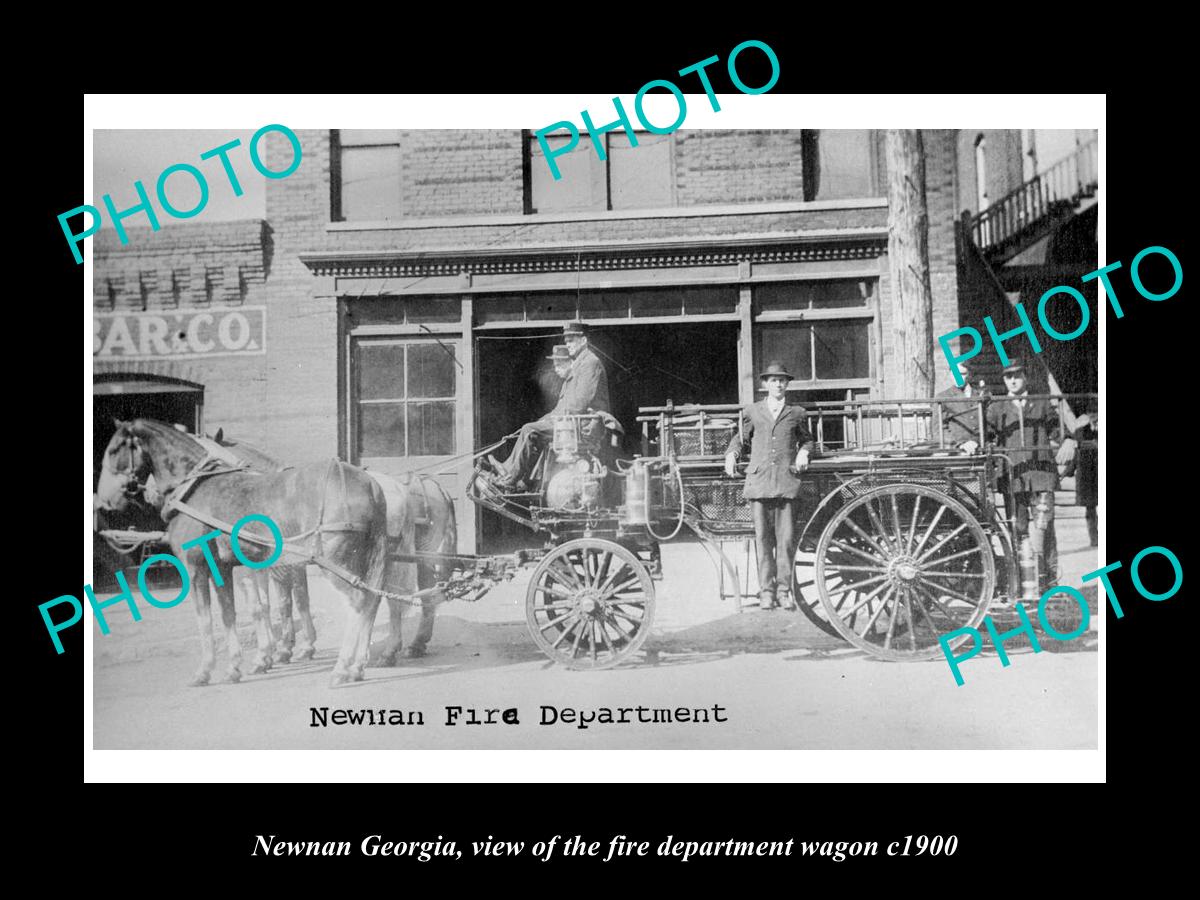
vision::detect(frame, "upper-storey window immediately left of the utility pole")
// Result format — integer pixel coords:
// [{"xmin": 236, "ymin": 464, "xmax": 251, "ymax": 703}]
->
[{"xmin": 800, "ymin": 128, "xmax": 887, "ymax": 200}]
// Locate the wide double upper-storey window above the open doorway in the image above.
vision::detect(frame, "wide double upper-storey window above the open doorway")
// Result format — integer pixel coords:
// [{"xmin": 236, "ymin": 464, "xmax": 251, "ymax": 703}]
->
[{"xmin": 528, "ymin": 131, "xmax": 676, "ymax": 212}]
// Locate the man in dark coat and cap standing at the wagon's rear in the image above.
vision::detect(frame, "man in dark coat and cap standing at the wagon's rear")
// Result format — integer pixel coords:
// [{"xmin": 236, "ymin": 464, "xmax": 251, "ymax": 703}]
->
[{"xmin": 988, "ymin": 358, "xmax": 1062, "ymax": 590}]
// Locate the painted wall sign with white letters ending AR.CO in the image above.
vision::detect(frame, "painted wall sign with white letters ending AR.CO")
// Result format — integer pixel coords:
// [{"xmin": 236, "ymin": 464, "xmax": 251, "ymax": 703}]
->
[{"xmin": 91, "ymin": 306, "xmax": 266, "ymax": 360}]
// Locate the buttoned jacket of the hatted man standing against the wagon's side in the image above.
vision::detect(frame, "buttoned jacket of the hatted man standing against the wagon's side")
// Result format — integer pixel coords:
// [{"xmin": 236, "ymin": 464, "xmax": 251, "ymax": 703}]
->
[{"xmin": 725, "ymin": 400, "xmax": 812, "ymax": 500}]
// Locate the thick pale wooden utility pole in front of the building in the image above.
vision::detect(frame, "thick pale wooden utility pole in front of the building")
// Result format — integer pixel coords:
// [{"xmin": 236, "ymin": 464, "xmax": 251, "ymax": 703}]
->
[{"xmin": 887, "ymin": 128, "xmax": 934, "ymax": 397}]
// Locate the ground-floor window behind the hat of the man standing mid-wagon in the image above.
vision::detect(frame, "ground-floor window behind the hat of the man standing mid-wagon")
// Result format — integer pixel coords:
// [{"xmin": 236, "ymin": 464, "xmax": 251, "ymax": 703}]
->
[{"xmin": 754, "ymin": 281, "xmax": 876, "ymax": 389}]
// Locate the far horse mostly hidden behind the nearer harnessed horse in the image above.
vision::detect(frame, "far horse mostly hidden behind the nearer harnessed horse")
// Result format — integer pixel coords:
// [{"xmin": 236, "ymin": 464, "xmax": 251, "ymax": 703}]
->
[{"xmin": 212, "ymin": 428, "xmax": 458, "ymax": 666}]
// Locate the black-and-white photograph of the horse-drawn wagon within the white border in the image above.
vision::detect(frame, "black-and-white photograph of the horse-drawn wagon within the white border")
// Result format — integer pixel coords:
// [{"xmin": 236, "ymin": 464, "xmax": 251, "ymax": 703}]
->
[{"xmin": 82, "ymin": 97, "xmax": 1099, "ymax": 766}]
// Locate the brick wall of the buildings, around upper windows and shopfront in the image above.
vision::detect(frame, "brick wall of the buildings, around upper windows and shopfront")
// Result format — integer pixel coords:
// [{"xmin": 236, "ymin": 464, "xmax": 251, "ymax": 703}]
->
[{"xmin": 88, "ymin": 131, "xmax": 974, "ymax": 472}]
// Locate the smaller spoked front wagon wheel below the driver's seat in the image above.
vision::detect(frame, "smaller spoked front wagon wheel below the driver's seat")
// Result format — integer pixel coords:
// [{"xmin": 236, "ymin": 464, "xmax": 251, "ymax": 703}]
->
[{"xmin": 526, "ymin": 538, "xmax": 654, "ymax": 668}]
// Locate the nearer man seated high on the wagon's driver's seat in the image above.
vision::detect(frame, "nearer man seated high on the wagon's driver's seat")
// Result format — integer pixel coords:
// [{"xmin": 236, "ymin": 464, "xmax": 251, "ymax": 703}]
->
[{"xmin": 493, "ymin": 322, "xmax": 610, "ymax": 492}]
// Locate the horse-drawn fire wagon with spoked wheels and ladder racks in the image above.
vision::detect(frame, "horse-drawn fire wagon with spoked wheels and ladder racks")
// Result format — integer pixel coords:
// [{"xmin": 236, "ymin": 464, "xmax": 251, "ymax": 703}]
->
[{"xmin": 467, "ymin": 395, "xmax": 1094, "ymax": 668}]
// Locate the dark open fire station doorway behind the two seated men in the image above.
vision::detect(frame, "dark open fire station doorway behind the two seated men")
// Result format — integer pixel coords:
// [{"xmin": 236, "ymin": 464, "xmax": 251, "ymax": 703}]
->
[{"xmin": 475, "ymin": 322, "xmax": 738, "ymax": 553}]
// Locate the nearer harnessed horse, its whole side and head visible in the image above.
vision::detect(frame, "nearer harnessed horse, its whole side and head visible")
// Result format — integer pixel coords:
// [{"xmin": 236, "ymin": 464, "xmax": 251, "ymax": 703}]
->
[{"xmin": 96, "ymin": 419, "xmax": 388, "ymax": 686}]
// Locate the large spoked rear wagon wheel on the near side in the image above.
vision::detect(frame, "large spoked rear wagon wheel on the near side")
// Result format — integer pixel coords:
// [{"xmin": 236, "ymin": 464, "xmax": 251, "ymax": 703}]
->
[{"xmin": 815, "ymin": 485, "xmax": 996, "ymax": 660}]
